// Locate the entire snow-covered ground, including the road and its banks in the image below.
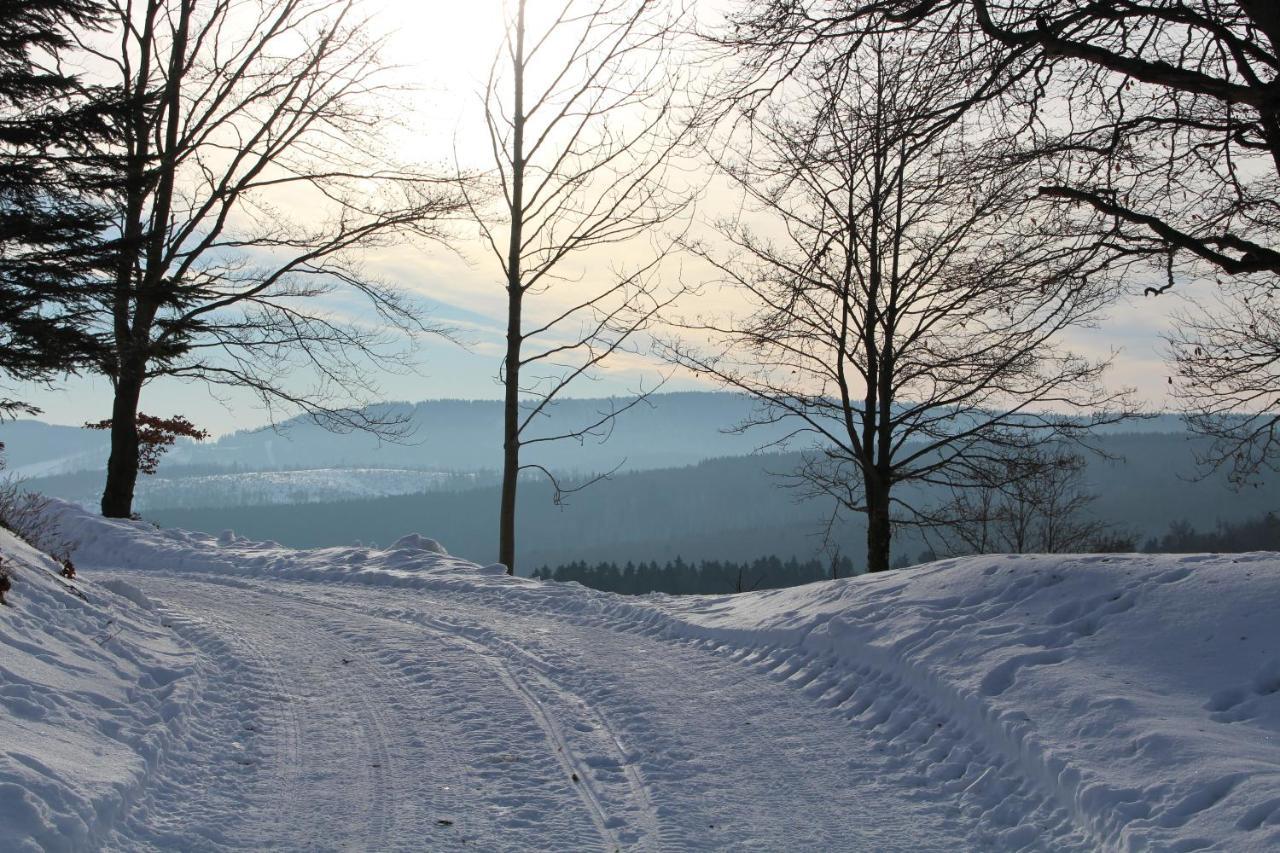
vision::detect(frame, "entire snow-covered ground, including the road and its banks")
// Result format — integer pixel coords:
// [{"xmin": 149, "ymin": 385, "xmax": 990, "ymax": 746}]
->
[{"xmin": 0, "ymin": 505, "xmax": 1280, "ymax": 850}]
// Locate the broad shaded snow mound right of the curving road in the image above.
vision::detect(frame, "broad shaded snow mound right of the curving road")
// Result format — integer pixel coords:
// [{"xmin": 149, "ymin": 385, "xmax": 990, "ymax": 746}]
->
[{"xmin": 664, "ymin": 555, "xmax": 1280, "ymax": 850}]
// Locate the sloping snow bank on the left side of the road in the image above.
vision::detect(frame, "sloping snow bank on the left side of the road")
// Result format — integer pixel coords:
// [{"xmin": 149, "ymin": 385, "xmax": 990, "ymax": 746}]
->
[{"xmin": 0, "ymin": 529, "xmax": 193, "ymax": 852}]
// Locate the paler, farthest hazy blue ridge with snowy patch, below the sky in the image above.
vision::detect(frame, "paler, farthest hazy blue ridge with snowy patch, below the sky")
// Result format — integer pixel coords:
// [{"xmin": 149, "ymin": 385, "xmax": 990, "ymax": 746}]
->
[{"xmin": 0, "ymin": 392, "xmax": 1181, "ymax": 476}]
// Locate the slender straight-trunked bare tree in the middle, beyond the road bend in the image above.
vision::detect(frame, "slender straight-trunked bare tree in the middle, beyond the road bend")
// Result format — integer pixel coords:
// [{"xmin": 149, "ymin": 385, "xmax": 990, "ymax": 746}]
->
[{"xmin": 471, "ymin": 0, "xmax": 691, "ymax": 573}]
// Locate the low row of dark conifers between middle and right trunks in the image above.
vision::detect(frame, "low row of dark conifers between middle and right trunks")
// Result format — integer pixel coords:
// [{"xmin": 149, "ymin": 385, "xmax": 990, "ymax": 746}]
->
[{"xmin": 532, "ymin": 556, "xmax": 854, "ymax": 596}]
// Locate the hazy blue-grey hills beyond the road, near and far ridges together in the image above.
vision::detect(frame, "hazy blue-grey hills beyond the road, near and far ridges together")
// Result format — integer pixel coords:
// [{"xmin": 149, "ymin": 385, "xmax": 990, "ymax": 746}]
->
[{"xmin": 0, "ymin": 393, "xmax": 1254, "ymax": 567}]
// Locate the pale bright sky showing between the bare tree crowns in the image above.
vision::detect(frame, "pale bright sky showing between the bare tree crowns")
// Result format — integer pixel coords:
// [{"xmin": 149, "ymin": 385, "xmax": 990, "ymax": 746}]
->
[{"xmin": 10, "ymin": 0, "xmax": 1179, "ymax": 434}]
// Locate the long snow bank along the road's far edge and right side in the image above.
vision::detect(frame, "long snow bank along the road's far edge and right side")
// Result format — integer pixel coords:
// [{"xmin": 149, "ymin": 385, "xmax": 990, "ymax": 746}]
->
[{"xmin": 45, "ymin": 494, "xmax": 1280, "ymax": 850}]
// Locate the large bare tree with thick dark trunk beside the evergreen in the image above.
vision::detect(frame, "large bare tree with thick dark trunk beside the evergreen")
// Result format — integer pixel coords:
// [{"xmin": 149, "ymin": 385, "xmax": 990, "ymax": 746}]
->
[{"xmin": 83, "ymin": 0, "xmax": 458, "ymax": 516}]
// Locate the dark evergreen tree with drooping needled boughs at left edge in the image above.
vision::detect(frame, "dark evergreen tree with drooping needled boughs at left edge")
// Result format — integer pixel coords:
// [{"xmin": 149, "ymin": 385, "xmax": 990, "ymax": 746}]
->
[{"xmin": 0, "ymin": 0, "xmax": 119, "ymax": 416}]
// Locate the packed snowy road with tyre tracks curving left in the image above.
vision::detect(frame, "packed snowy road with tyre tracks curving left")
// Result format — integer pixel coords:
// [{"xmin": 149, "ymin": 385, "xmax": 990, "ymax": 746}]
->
[{"xmin": 107, "ymin": 573, "xmax": 1069, "ymax": 850}]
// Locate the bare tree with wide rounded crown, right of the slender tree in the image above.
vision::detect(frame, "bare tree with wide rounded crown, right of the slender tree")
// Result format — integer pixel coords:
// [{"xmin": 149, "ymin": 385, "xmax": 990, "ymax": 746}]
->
[{"xmin": 669, "ymin": 32, "xmax": 1128, "ymax": 571}]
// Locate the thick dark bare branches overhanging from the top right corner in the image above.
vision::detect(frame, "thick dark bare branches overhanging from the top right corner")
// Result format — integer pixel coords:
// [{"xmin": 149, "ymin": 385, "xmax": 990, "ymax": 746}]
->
[{"xmin": 739, "ymin": 0, "xmax": 1280, "ymax": 274}]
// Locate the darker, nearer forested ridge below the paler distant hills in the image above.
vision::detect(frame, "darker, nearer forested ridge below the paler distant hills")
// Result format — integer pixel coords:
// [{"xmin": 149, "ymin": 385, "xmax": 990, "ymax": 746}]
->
[{"xmin": 145, "ymin": 433, "xmax": 1280, "ymax": 571}]
